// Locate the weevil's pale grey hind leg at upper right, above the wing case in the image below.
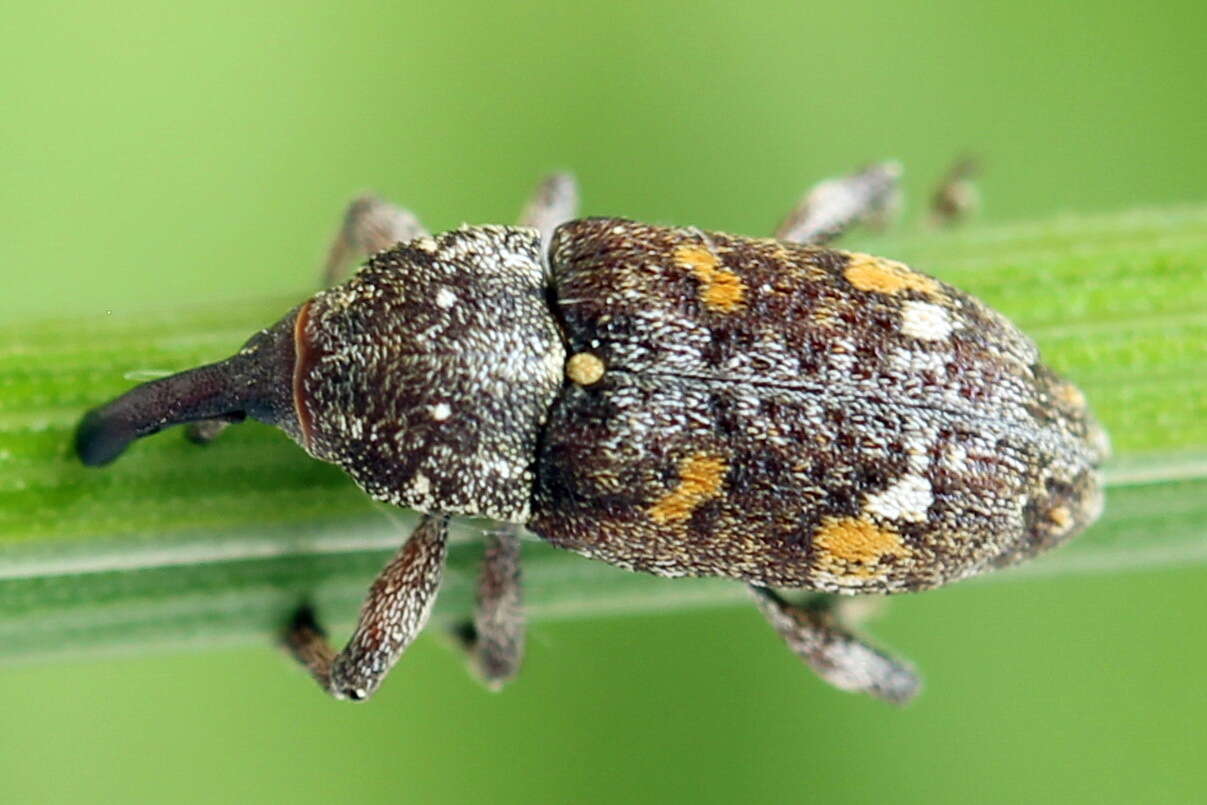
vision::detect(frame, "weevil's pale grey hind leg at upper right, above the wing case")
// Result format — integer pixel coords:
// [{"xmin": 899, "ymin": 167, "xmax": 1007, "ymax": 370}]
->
[{"xmin": 775, "ymin": 162, "xmax": 902, "ymax": 244}]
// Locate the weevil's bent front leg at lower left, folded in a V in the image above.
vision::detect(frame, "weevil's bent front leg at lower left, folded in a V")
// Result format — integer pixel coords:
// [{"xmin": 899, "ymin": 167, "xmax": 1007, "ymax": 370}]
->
[{"xmin": 285, "ymin": 514, "xmax": 449, "ymax": 701}]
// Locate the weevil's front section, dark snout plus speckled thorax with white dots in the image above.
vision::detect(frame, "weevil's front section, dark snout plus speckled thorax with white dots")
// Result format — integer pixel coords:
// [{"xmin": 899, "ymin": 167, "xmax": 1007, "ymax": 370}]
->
[{"xmin": 76, "ymin": 227, "xmax": 565, "ymax": 521}]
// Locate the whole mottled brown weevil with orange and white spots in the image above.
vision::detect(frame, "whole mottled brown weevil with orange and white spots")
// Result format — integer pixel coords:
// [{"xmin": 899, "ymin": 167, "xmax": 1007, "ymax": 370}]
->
[{"xmin": 76, "ymin": 163, "xmax": 1108, "ymax": 702}]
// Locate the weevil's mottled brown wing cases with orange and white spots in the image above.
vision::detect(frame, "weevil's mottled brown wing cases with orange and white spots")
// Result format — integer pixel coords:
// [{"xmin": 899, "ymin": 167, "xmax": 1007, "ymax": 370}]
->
[{"xmin": 530, "ymin": 218, "xmax": 1106, "ymax": 593}]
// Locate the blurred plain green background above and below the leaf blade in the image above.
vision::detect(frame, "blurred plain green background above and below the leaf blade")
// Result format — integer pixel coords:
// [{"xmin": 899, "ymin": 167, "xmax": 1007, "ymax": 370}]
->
[{"xmin": 0, "ymin": 0, "xmax": 1207, "ymax": 804}]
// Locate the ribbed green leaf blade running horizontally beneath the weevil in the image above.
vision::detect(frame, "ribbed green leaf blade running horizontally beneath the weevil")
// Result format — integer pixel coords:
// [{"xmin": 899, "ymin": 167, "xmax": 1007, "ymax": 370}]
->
[{"xmin": 0, "ymin": 206, "xmax": 1207, "ymax": 657}]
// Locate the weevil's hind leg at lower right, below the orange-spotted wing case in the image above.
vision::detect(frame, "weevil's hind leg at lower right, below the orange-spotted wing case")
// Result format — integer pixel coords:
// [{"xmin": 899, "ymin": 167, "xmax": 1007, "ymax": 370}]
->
[{"xmin": 750, "ymin": 585, "xmax": 921, "ymax": 705}]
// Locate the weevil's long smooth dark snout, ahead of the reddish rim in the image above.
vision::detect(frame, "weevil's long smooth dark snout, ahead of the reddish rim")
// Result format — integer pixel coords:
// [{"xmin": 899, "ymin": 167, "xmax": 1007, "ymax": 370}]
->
[{"xmin": 75, "ymin": 310, "xmax": 298, "ymax": 467}]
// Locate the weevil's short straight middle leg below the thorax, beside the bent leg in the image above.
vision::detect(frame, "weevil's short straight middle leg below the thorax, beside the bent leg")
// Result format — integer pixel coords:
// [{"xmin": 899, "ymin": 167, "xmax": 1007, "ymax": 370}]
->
[{"xmin": 454, "ymin": 524, "xmax": 525, "ymax": 690}]
